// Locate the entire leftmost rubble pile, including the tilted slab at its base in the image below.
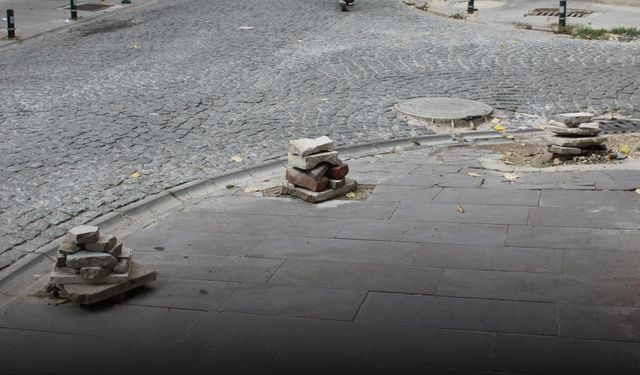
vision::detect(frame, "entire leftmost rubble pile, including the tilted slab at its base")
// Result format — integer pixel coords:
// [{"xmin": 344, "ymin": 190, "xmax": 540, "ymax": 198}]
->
[{"xmin": 49, "ymin": 225, "xmax": 156, "ymax": 304}]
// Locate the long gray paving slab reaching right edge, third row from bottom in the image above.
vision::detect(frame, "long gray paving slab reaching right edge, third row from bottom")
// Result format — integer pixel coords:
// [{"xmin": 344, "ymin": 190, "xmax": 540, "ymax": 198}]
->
[{"xmin": 435, "ymin": 269, "xmax": 640, "ymax": 306}]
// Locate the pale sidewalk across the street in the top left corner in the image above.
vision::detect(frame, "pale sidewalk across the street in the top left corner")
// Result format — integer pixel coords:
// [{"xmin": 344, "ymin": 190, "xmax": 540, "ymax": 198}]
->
[{"xmin": 0, "ymin": 0, "xmax": 154, "ymax": 47}]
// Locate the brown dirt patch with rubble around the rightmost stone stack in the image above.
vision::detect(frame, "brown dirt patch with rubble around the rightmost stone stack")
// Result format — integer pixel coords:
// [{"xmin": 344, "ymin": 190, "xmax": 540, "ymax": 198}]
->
[{"xmin": 474, "ymin": 134, "xmax": 640, "ymax": 168}]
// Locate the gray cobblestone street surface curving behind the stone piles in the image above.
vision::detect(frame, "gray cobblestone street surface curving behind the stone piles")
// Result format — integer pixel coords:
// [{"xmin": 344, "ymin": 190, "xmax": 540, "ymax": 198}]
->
[{"xmin": 0, "ymin": 0, "xmax": 640, "ymax": 268}]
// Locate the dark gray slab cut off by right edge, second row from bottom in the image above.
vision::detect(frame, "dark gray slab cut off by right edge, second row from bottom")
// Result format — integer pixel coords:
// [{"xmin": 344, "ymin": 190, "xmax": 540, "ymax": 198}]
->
[{"xmin": 558, "ymin": 303, "xmax": 640, "ymax": 343}]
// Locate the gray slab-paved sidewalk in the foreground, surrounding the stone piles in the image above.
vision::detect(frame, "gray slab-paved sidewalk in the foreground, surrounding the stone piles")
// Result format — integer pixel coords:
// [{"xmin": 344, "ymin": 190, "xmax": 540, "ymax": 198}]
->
[{"xmin": 0, "ymin": 139, "xmax": 640, "ymax": 374}]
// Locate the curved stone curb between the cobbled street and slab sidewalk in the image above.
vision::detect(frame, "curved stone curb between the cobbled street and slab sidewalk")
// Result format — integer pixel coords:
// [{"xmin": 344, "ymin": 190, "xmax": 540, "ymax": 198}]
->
[{"xmin": 0, "ymin": 132, "xmax": 516, "ymax": 283}]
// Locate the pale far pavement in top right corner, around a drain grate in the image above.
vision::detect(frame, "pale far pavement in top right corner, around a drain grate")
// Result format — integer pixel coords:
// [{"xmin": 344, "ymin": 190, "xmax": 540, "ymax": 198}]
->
[{"xmin": 427, "ymin": 0, "xmax": 640, "ymax": 29}]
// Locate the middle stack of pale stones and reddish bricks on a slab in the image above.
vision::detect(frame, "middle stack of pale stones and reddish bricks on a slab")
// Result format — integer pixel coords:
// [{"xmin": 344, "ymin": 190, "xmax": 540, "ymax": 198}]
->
[{"xmin": 284, "ymin": 136, "xmax": 358, "ymax": 203}]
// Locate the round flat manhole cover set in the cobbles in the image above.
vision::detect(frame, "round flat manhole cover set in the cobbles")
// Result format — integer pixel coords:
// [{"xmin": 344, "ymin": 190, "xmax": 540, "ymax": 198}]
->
[{"xmin": 396, "ymin": 98, "xmax": 493, "ymax": 122}]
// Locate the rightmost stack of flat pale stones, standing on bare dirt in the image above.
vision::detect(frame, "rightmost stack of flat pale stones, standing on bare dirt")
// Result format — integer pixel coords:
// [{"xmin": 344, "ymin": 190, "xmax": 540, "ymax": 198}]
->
[{"xmin": 547, "ymin": 112, "xmax": 607, "ymax": 157}]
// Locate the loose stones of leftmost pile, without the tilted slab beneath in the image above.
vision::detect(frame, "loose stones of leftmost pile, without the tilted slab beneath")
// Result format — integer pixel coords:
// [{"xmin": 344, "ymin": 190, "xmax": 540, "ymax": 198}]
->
[{"xmin": 51, "ymin": 225, "xmax": 133, "ymax": 285}]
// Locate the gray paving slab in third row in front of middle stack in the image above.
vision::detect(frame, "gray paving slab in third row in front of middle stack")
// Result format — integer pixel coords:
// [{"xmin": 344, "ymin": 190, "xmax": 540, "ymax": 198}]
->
[{"xmin": 248, "ymin": 237, "xmax": 420, "ymax": 265}]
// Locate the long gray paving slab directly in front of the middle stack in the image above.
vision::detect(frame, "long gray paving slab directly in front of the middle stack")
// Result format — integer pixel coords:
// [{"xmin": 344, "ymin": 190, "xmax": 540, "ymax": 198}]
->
[{"xmin": 189, "ymin": 197, "xmax": 397, "ymax": 219}]
